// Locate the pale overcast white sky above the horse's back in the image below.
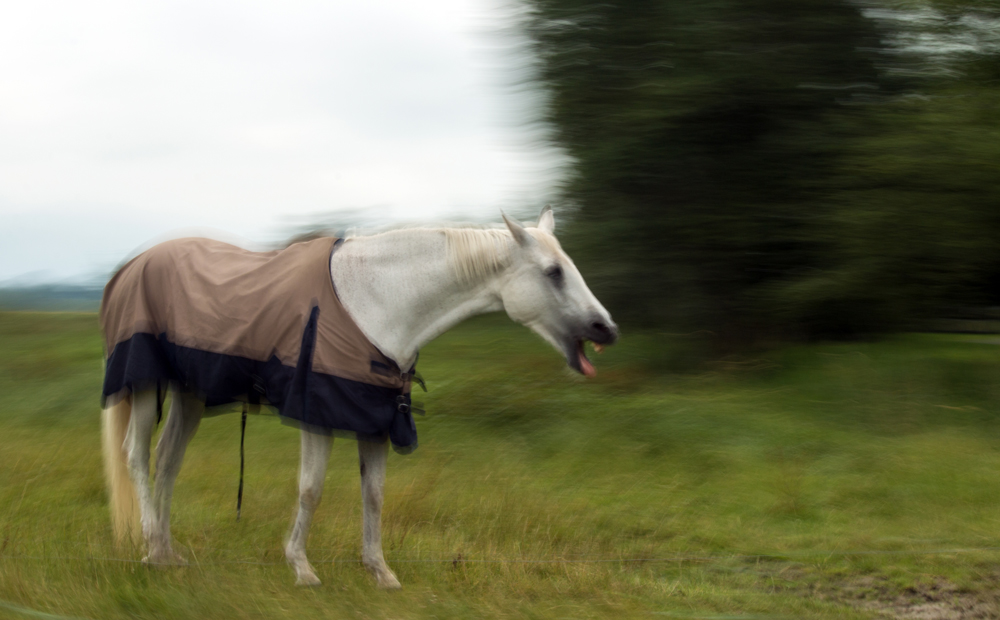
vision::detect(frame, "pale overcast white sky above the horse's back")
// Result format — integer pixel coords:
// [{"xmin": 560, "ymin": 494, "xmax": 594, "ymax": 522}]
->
[{"xmin": 0, "ymin": 0, "xmax": 562, "ymax": 281}]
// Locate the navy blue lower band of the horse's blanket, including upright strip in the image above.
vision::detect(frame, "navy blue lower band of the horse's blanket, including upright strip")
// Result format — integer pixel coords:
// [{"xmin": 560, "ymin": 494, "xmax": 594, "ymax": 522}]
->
[{"xmin": 104, "ymin": 332, "xmax": 417, "ymax": 453}]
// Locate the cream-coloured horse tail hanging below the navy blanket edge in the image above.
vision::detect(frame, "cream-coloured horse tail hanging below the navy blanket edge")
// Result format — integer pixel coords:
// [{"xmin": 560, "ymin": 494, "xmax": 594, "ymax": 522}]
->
[{"xmin": 101, "ymin": 395, "xmax": 140, "ymax": 544}]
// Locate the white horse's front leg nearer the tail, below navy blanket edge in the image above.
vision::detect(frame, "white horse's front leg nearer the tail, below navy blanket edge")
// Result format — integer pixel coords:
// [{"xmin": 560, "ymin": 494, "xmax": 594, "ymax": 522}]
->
[{"xmin": 285, "ymin": 430, "xmax": 333, "ymax": 586}]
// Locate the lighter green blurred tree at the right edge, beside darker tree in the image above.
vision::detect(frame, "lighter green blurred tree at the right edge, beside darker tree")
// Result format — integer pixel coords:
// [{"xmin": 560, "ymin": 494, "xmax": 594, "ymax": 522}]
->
[{"xmin": 792, "ymin": 89, "xmax": 1000, "ymax": 335}]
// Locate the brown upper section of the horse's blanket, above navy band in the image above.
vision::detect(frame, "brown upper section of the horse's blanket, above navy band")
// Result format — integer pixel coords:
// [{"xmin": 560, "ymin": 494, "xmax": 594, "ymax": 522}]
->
[{"xmin": 101, "ymin": 238, "xmax": 409, "ymax": 389}]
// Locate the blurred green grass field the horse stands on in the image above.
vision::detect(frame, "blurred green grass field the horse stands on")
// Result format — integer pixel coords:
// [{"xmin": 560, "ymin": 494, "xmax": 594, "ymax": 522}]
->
[{"xmin": 0, "ymin": 313, "xmax": 1000, "ymax": 620}]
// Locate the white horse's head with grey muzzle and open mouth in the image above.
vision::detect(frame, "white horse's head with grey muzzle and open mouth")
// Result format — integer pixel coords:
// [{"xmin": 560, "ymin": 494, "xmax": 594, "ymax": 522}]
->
[{"xmin": 500, "ymin": 207, "xmax": 618, "ymax": 377}]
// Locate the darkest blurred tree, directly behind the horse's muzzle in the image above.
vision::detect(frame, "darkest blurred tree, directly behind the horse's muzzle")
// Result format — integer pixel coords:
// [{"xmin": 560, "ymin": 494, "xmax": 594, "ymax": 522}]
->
[{"xmin": 527, "ymin": 0, "xmax": 881, "ymax": 339}]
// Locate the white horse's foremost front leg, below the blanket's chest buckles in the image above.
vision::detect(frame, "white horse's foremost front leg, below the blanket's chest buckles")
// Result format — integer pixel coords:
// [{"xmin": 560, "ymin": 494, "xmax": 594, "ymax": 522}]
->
[{"xmin": 358, "ymin": 440, "xmax": 402, "ymax": 589}]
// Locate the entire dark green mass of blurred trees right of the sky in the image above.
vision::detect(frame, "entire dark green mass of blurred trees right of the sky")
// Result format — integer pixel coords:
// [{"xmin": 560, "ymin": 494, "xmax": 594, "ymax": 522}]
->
[{"xmin": 524, "ymin": 0, "xmax": 1000, "ymax": 348}]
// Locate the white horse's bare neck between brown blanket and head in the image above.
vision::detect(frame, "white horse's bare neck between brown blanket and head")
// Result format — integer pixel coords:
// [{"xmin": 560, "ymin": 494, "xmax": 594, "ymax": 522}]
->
[{"xmin": 330, "ymin": 230, "xmax": 503, "ymax": 370}]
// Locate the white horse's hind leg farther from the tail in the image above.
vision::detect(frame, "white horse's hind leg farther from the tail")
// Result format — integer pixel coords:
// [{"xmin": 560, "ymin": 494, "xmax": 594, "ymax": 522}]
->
[{"xmin": 147, "ymin": 389, "xmax": 205, "ymax": 564}]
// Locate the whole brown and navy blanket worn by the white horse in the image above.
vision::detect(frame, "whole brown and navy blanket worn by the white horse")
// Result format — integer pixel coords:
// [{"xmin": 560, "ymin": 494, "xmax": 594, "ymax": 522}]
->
[{"xmin": 100, "ymin": 238, "xmax": 417, "ymax": 452}]
